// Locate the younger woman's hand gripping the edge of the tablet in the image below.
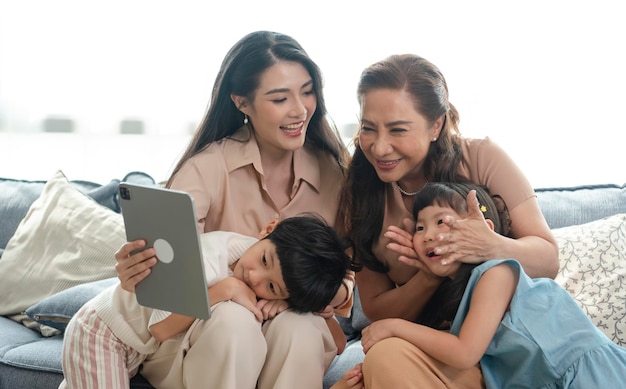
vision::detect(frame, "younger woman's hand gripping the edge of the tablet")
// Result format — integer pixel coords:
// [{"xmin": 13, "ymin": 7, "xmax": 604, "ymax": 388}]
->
[{"xmin": 115, "ymin": 240, "xmax": 157, "ymax": 293}]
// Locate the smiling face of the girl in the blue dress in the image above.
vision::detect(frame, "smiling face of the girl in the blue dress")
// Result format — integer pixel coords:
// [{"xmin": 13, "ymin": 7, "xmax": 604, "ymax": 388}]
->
[{"xmin": 413, "ymin": 204, "xmax": 465, "ymax": 278}]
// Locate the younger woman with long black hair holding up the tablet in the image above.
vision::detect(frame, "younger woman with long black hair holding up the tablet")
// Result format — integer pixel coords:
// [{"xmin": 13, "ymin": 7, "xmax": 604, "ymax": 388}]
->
[{"xmin": 111, "ymin": 31, "xmax": 353, "ymax": 389}]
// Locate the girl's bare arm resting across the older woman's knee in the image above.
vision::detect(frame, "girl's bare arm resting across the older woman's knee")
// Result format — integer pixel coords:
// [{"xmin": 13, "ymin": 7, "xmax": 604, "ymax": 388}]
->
[{"xmin": 362, "ymin": 264, "xmax": 518, "ymax": 369}]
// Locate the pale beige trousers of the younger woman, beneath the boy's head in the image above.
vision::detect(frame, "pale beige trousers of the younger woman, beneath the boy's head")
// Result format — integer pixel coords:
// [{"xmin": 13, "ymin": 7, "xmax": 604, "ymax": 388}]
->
[{"xmin": 141, "ymin": 301, "xmax": 337, "ymax": 389}]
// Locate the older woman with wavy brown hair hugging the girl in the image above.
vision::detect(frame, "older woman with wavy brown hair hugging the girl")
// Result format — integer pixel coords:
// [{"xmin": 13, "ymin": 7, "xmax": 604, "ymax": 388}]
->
[{"xmin": 341, "ymin": 54, "xmax": 559, "ymax": 387}]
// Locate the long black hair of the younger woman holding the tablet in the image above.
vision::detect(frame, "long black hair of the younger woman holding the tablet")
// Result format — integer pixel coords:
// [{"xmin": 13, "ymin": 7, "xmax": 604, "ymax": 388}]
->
[{"xmin": 168, "ymin": 31, "xmax": 348, "ymax": 186}]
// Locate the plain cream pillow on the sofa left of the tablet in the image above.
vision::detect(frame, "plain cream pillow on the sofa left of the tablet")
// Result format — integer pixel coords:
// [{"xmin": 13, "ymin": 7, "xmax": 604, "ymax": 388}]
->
[{"xmin": 0, "ymin": 171, "xmax": 126, "ymax": 315}]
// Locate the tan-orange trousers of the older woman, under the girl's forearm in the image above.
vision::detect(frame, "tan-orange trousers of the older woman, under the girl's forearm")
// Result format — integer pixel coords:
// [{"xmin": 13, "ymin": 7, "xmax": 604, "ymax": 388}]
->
[{"xmin": 332, "ymin": 338, "xmax": 485, "ymax": 389}]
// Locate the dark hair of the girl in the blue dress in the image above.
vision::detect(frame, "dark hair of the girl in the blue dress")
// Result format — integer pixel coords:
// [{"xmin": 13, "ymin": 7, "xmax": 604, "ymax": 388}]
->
[{"xmin": 413, "ymin": 183, "xmax": 511, "ymax": 329}]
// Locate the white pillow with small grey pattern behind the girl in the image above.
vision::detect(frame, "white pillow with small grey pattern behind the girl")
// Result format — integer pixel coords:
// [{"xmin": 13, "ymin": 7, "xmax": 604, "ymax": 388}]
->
[{"xmin": 553, "ymin": 214, "xmax": 626, "ymax": 346}]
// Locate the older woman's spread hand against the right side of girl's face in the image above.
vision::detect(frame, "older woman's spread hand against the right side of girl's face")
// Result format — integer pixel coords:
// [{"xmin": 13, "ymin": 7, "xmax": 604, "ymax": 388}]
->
[{"xmin": 428, "ymin": 190, "xmax": 496, "ymax": 265}]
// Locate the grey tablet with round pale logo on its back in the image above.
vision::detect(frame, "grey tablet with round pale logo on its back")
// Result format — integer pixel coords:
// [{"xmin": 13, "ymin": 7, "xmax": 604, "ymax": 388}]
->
[{"xmin": 118, "ymin": 182, "xmax": 211, "ymax": 319}]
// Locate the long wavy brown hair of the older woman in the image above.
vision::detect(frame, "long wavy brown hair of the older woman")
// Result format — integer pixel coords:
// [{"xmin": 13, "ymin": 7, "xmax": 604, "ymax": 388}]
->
[{"xmin": 341, "ymin": 54, "xmax": 463, "ymax": 272}]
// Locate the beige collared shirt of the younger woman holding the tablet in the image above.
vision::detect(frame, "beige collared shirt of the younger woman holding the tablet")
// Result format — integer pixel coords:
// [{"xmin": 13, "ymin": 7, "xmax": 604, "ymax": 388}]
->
[{"xmin": 171, "ymin": 127, "xmax": 354, "ymax": 316}]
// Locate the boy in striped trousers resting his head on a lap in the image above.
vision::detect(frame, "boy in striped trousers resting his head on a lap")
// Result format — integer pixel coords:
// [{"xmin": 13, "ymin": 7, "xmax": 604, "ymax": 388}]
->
[{"xmin": 60, "ymin": 214, "xmax": 351, "ymax": 388}]
